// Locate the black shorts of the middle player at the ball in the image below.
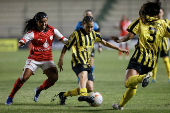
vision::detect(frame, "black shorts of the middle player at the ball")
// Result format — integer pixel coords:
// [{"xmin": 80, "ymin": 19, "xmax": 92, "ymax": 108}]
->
[{"xmin": 72, "ymin": 64, "xmax": 94, "ymax": 81}]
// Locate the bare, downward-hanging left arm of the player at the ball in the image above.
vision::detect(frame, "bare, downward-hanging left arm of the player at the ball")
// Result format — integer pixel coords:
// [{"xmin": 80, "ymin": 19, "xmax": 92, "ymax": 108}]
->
[{"xmin": 58, "ymin": 46, "xmax": 67, "ymax": 72}]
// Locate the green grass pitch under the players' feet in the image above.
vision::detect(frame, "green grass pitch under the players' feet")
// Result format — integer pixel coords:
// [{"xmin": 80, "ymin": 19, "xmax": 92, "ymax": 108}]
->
[{"xmin": 0, "ymin": 50, "xmax": 170, "ymax": 113}]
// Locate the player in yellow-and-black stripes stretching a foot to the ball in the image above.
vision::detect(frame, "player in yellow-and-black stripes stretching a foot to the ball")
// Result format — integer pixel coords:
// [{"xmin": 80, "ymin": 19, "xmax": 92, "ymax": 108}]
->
[{"xmin": 54, "ymin": 16, "xmax": 128, "ymax": 105}]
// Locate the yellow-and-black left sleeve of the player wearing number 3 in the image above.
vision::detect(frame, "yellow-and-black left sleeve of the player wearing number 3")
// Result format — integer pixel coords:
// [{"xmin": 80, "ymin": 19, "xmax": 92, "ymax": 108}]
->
[{"xmin": 127, "ymin": 18, "xmax": 140, "ymax": 35}]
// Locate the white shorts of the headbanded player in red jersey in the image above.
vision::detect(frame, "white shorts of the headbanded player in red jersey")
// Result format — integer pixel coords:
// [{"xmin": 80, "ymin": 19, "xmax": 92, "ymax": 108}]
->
[{"xmin": 24, "ymin": 59, "xmax": 56, "ymax": 74}]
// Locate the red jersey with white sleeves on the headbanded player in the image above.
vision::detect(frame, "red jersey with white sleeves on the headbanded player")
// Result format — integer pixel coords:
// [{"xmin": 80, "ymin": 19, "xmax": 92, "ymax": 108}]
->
[{"xmin": 20, "ymin": 25, "xmax": 65, "ymax": 61}]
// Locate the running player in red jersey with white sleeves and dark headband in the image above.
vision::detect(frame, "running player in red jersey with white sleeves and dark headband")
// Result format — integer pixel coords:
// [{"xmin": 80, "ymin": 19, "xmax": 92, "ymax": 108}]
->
[{"xmin": 5, "ymin": 12, "xmax": 67, "ymax": 105}]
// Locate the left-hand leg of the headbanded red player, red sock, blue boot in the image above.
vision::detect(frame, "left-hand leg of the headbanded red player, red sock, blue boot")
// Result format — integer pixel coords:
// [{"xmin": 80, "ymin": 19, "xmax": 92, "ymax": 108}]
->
[{"xmin": 5, "ymin": 68, "xmax": 33, "ymax": 105}]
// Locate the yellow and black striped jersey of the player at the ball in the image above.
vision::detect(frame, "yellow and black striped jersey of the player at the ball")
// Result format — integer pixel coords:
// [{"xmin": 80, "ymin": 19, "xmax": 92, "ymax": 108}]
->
[{"xmin": 65, "ymin": 28, "xmax": 102, "ymax": 67}]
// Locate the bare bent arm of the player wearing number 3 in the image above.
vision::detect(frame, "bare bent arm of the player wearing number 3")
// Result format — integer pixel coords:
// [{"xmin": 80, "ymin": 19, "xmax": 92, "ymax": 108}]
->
[{"xmin": 110, "ymin": 32, "xmax": 135, "ymax": 43}]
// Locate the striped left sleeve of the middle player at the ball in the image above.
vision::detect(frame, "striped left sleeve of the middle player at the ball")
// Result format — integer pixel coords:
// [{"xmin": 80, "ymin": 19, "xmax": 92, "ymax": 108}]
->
[{"xmin": 65, "ymin": 32, "xmax": 76, "ymax": 50}]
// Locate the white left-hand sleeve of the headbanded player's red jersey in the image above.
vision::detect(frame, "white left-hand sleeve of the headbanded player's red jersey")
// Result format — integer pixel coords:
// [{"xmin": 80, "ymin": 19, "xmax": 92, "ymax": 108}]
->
[{"xmin": 19, "ymin": 31, "xmax": 34, "ymax": 44}]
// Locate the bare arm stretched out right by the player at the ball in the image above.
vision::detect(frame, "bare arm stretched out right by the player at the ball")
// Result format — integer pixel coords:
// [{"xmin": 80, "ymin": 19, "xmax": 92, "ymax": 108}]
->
[{"xmin": 101, "ymin": 39, "xmax": 129, "ymax": 54}]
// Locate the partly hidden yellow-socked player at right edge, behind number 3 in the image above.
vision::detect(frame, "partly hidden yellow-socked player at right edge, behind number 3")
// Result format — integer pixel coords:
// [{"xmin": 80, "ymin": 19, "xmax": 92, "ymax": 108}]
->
[{"xmin": 152, "ymin": 8, "xmax": 170, "ymax": 83}]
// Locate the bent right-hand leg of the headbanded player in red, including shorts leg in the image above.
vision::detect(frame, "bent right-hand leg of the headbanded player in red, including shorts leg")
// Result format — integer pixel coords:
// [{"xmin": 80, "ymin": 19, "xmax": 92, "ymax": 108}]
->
[{"xmin": 33, "ymin": 61, "xmax": 58, "ymax": 102}]
